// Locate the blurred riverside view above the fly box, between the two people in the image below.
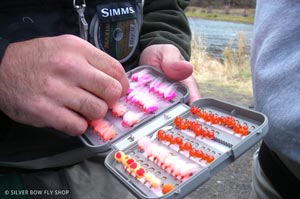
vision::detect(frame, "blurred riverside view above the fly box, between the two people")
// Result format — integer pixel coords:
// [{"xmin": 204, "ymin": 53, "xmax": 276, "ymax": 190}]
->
[{"xmin": 186, "ymin": 0, "xmax": 255, "ymax": 107}]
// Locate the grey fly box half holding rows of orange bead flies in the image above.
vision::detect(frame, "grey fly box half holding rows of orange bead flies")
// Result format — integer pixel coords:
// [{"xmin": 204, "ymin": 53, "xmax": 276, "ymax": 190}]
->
[{"xmin": 105, "ymin": 98, "xmax": 268, "ymax": 199}]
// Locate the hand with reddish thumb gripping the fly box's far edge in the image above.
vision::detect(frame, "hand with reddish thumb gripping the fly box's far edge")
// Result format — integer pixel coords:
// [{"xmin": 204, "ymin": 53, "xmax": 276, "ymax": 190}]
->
[{"xmin": 139, "ymin": 44, "xmax": 201, "ymax": 104}]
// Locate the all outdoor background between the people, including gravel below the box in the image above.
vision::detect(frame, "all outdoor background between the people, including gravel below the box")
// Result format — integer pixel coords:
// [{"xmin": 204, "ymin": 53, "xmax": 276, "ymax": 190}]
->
[{"xmin": 186, "ymin": 0, "xmax": 259, "ymax": 199}]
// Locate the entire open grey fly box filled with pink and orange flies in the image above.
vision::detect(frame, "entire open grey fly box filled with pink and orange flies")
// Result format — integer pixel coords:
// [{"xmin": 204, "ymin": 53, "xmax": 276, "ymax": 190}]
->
[{"xmin": 82, "ymin": 66, "xmax": 268, "ymax": 199}]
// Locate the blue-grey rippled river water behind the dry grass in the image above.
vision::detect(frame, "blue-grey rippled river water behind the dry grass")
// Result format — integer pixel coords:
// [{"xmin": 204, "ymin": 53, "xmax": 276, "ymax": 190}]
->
[{"xmin": 189, "ymin": 18, "xmax": 253, "ymax": 59}]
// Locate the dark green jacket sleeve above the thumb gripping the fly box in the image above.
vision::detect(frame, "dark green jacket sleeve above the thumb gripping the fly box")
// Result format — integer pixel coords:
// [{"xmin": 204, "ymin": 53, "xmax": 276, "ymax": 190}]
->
[{"xmin": 140, "ymin": 0, "xmax": 191, "ymax": 60}]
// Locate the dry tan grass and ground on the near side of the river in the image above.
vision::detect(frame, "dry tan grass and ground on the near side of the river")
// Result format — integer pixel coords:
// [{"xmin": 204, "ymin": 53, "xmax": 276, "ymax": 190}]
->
[{"xmin": 191, "ymin": 32, "xmax": 252, "ymax": 107}]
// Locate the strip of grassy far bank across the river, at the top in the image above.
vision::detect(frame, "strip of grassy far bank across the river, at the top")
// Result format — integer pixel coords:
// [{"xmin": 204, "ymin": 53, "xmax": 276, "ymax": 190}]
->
[{"xmin": 185, "ymin": 6, "xmax": 255, "ymax": 24}]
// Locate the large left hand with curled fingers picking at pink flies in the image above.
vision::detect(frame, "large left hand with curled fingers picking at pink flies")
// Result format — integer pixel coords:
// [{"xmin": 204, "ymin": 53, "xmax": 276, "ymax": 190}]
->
[{"xmin": 0, "ymin": 35, "xmax": 129, "ymax": 135}]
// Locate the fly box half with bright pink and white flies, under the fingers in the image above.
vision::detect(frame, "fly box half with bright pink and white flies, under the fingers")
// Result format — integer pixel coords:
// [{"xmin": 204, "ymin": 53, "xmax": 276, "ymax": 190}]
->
[{"xmin": 80, "ymin": 66, "xmax": 189, "ymax": 153}]
